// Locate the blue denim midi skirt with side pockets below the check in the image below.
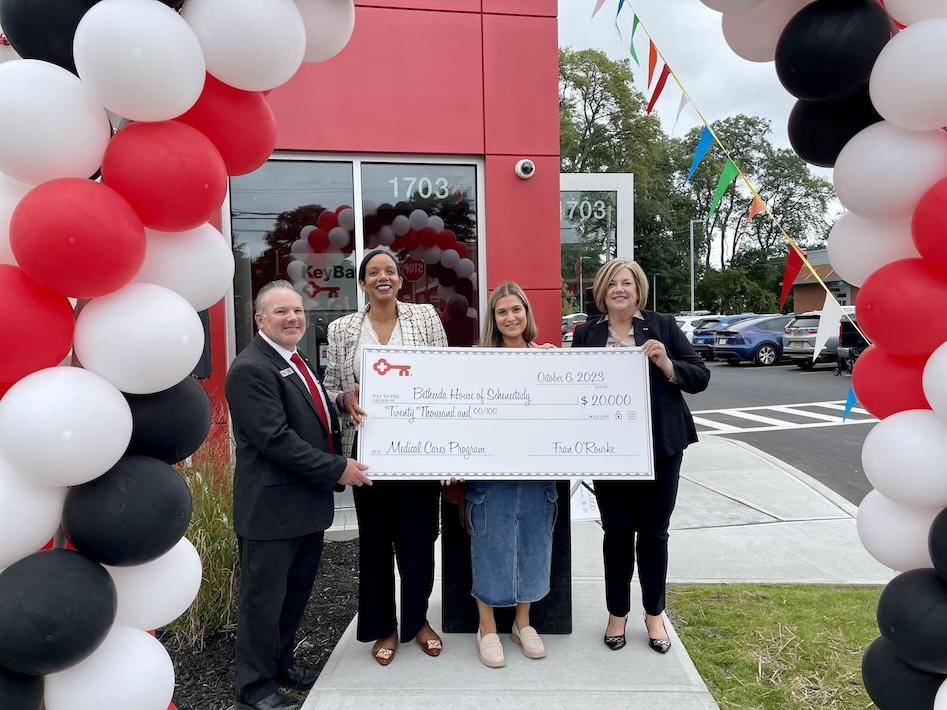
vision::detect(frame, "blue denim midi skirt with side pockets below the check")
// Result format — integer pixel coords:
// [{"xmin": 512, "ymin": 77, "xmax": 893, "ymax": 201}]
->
[{"xmin": 465, "ymin": 481, "xmax": 556, "ymax": 606}]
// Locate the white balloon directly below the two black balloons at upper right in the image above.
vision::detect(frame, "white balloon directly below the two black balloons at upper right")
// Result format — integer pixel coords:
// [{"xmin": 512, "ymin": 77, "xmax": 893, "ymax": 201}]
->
[{"xmin": 835, "ymin": 121, "xmax": 947, "ymax": 219}]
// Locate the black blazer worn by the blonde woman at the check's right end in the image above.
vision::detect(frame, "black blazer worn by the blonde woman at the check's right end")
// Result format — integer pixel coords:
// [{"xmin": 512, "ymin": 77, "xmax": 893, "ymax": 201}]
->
[{"xmin": 572, "ymin": 311, "xmax": 710, "ymax": 456}]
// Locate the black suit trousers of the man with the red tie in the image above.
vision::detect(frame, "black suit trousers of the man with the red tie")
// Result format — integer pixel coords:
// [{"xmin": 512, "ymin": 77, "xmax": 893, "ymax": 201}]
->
[{"xmin": 236, "ymin": 532, "xmax": 323, "ymax": 704}]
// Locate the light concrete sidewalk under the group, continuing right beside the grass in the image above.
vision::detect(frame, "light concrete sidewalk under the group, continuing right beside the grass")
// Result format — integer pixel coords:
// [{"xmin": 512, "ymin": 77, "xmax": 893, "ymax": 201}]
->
[{"xmin": 303, "ymin": 437, "xmax": 894, "ymax": 710}]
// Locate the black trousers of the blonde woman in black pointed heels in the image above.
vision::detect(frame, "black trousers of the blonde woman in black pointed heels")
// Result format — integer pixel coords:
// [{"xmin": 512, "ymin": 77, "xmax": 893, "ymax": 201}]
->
[{"xmin": 595, "ymin": 452, "xmax": 684, "ymax": 616}]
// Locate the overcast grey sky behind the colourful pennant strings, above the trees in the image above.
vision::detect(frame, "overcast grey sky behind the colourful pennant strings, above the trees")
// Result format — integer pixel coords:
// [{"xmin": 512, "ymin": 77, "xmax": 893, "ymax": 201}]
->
[{"xmin": 559, "ymin": 0, "xmax": 808, "ymax": 156}]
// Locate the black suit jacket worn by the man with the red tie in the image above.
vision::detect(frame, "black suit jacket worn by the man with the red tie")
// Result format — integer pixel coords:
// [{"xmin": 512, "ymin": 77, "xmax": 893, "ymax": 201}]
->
[{"xmin": 226, "ymin": 334, "xmax": 346, "ymax": 540}]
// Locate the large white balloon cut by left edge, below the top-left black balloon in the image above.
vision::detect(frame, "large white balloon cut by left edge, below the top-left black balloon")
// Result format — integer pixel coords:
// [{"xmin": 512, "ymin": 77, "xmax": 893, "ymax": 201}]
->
[{"xmin": 0, "ymin": 60, "xmax": 110, "ymax": 185}]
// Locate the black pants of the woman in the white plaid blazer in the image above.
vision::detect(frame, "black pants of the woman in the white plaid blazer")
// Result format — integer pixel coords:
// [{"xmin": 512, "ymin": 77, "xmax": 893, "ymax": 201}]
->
[{"xmin": 353, "ymin": 481, "xmax": 441, "ymax": 642}]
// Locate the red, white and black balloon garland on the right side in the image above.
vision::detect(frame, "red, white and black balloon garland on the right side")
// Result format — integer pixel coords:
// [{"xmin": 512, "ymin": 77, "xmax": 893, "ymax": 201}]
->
[{"xmin": 701, "ymin": 0, "xmax": 947, "ymax": 710}]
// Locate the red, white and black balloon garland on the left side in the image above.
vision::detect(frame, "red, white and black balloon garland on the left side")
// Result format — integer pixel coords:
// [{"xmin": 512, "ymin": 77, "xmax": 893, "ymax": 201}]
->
[{"xmin": 0, "ymin": 0, "xmax": 355, "ymax": 710}]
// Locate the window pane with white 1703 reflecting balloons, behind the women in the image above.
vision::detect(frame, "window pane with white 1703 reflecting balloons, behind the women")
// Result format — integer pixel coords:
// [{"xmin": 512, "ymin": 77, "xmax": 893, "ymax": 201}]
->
[{"xmin": 361, "ymin": 163, "xmax": 479, "ymax": 346}]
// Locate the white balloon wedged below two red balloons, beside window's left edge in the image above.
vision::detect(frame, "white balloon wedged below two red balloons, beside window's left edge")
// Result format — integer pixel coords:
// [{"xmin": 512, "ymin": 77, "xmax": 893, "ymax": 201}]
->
[{"xmin": 132, "ymin": 224, "xmax": 234, "ymax": 311}]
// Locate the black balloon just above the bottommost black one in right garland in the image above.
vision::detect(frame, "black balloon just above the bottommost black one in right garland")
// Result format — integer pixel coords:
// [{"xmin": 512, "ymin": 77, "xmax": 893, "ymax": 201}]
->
[{"xmin": 878, "ymin": 569, "xmax": 947, "ymax": 673}]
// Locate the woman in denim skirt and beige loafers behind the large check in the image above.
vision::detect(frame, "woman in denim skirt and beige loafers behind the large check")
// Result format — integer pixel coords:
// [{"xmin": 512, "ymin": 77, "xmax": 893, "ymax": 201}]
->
[{"xmin": 465, "ymin": 282, "xmax": 556, "ymax": 668}]
